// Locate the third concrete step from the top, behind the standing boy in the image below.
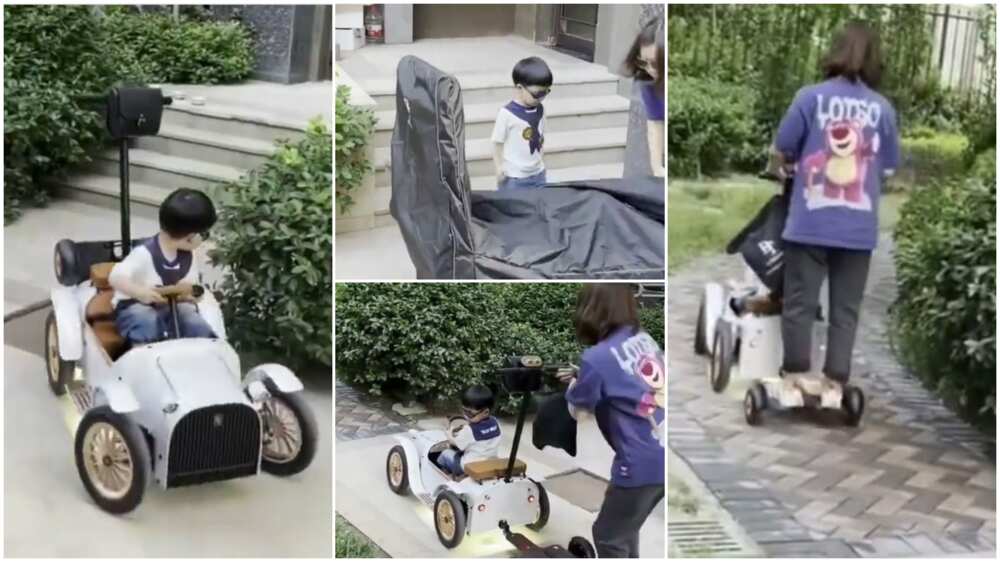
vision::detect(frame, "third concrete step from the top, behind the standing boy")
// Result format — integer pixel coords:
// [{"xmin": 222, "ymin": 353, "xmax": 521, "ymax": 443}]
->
[{"xmin": 375, "ymin": 127, "xmax": 627, "ymax": 187}]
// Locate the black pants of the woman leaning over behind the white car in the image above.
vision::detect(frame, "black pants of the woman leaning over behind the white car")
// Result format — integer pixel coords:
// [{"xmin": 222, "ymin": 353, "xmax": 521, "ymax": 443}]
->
[{"xmin": 592, "ymin": 484, "xmax": 663, "ymax": 558}]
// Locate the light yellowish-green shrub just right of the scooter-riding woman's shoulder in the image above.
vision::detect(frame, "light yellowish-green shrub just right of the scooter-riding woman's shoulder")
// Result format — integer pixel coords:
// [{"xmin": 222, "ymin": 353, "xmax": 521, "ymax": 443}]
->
[{"xmin": 899, "ymin": 127, "xmax": 969, "ymax": 185}]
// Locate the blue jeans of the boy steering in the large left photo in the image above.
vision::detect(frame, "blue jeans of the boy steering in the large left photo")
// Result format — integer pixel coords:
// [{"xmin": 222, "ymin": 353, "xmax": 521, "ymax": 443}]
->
[{"xmin": 115, "ymin": 302, "xmax": 215, "ymax": 343}]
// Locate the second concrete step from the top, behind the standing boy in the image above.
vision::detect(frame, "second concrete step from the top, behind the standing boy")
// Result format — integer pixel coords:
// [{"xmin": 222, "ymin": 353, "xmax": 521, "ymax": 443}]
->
[{"xmin": 375, "ymin": 95, "xmax": 629, "ymax": 147}]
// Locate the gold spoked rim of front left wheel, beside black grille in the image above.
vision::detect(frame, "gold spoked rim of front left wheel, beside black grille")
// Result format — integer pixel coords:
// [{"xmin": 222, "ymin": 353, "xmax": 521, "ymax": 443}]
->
[{"xmin": 83, "ymin": 422, "xmax": 135, "ymax": 500}]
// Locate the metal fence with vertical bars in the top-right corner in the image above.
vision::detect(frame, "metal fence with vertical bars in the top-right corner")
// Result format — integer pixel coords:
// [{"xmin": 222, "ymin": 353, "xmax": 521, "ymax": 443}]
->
[{"xmin": 927, "ymin": 4, "xmax": 996, "ymax": 92}]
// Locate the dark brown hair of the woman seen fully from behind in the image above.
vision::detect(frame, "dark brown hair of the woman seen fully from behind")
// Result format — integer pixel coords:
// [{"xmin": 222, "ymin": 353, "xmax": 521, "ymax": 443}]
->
[{"xmin": 820, "ymin": 21, "xmax": 884, "ymax": 90}]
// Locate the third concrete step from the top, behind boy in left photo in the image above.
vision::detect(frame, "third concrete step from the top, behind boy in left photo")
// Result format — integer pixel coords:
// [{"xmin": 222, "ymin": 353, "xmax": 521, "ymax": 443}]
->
[{"xmin": 86, "ymin": 148, "xmax": 244, "ymax": 191}]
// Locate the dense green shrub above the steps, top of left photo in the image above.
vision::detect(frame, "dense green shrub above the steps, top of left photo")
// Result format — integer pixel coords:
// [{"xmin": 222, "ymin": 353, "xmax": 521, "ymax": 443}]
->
[{"xmin": 102, "ymin": 7, "xmax": 254, "ymax": 84}]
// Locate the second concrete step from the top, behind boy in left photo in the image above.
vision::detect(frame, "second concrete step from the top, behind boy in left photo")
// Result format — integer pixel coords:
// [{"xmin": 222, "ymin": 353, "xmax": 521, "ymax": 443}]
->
[{"xmin": 136, "ymin": 123, "xmax": 274, "ymax": 170}]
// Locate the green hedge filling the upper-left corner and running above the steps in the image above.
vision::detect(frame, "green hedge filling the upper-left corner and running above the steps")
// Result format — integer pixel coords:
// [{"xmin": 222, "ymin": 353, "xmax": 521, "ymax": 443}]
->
[{"xmin": 4, "ymin": 5, "xmax": 253, "ymax": 221}]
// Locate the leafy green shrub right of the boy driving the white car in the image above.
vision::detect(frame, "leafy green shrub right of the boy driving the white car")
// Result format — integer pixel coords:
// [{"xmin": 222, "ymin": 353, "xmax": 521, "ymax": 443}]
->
[{"xmin": 210, "ymin": 121, "xmax": 333, "ymax": 365}]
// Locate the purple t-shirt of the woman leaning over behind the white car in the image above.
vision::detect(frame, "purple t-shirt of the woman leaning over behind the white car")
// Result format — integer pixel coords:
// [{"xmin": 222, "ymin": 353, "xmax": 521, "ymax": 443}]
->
[{"xmin": 566, "ymin": 328, "xmax": 666, "ymax": 488}]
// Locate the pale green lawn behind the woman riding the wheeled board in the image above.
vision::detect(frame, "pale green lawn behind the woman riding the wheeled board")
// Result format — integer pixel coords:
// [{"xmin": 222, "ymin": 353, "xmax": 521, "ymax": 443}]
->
[{"xmin": 667, "ymin": 175, "xmax": 907, "ymax": 272}]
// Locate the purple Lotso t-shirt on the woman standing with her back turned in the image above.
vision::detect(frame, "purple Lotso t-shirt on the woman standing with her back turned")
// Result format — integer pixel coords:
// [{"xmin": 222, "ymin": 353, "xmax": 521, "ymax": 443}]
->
[{"xmin": 775, "ymin": 77, "xmax": 899, "ymax": 250}]
